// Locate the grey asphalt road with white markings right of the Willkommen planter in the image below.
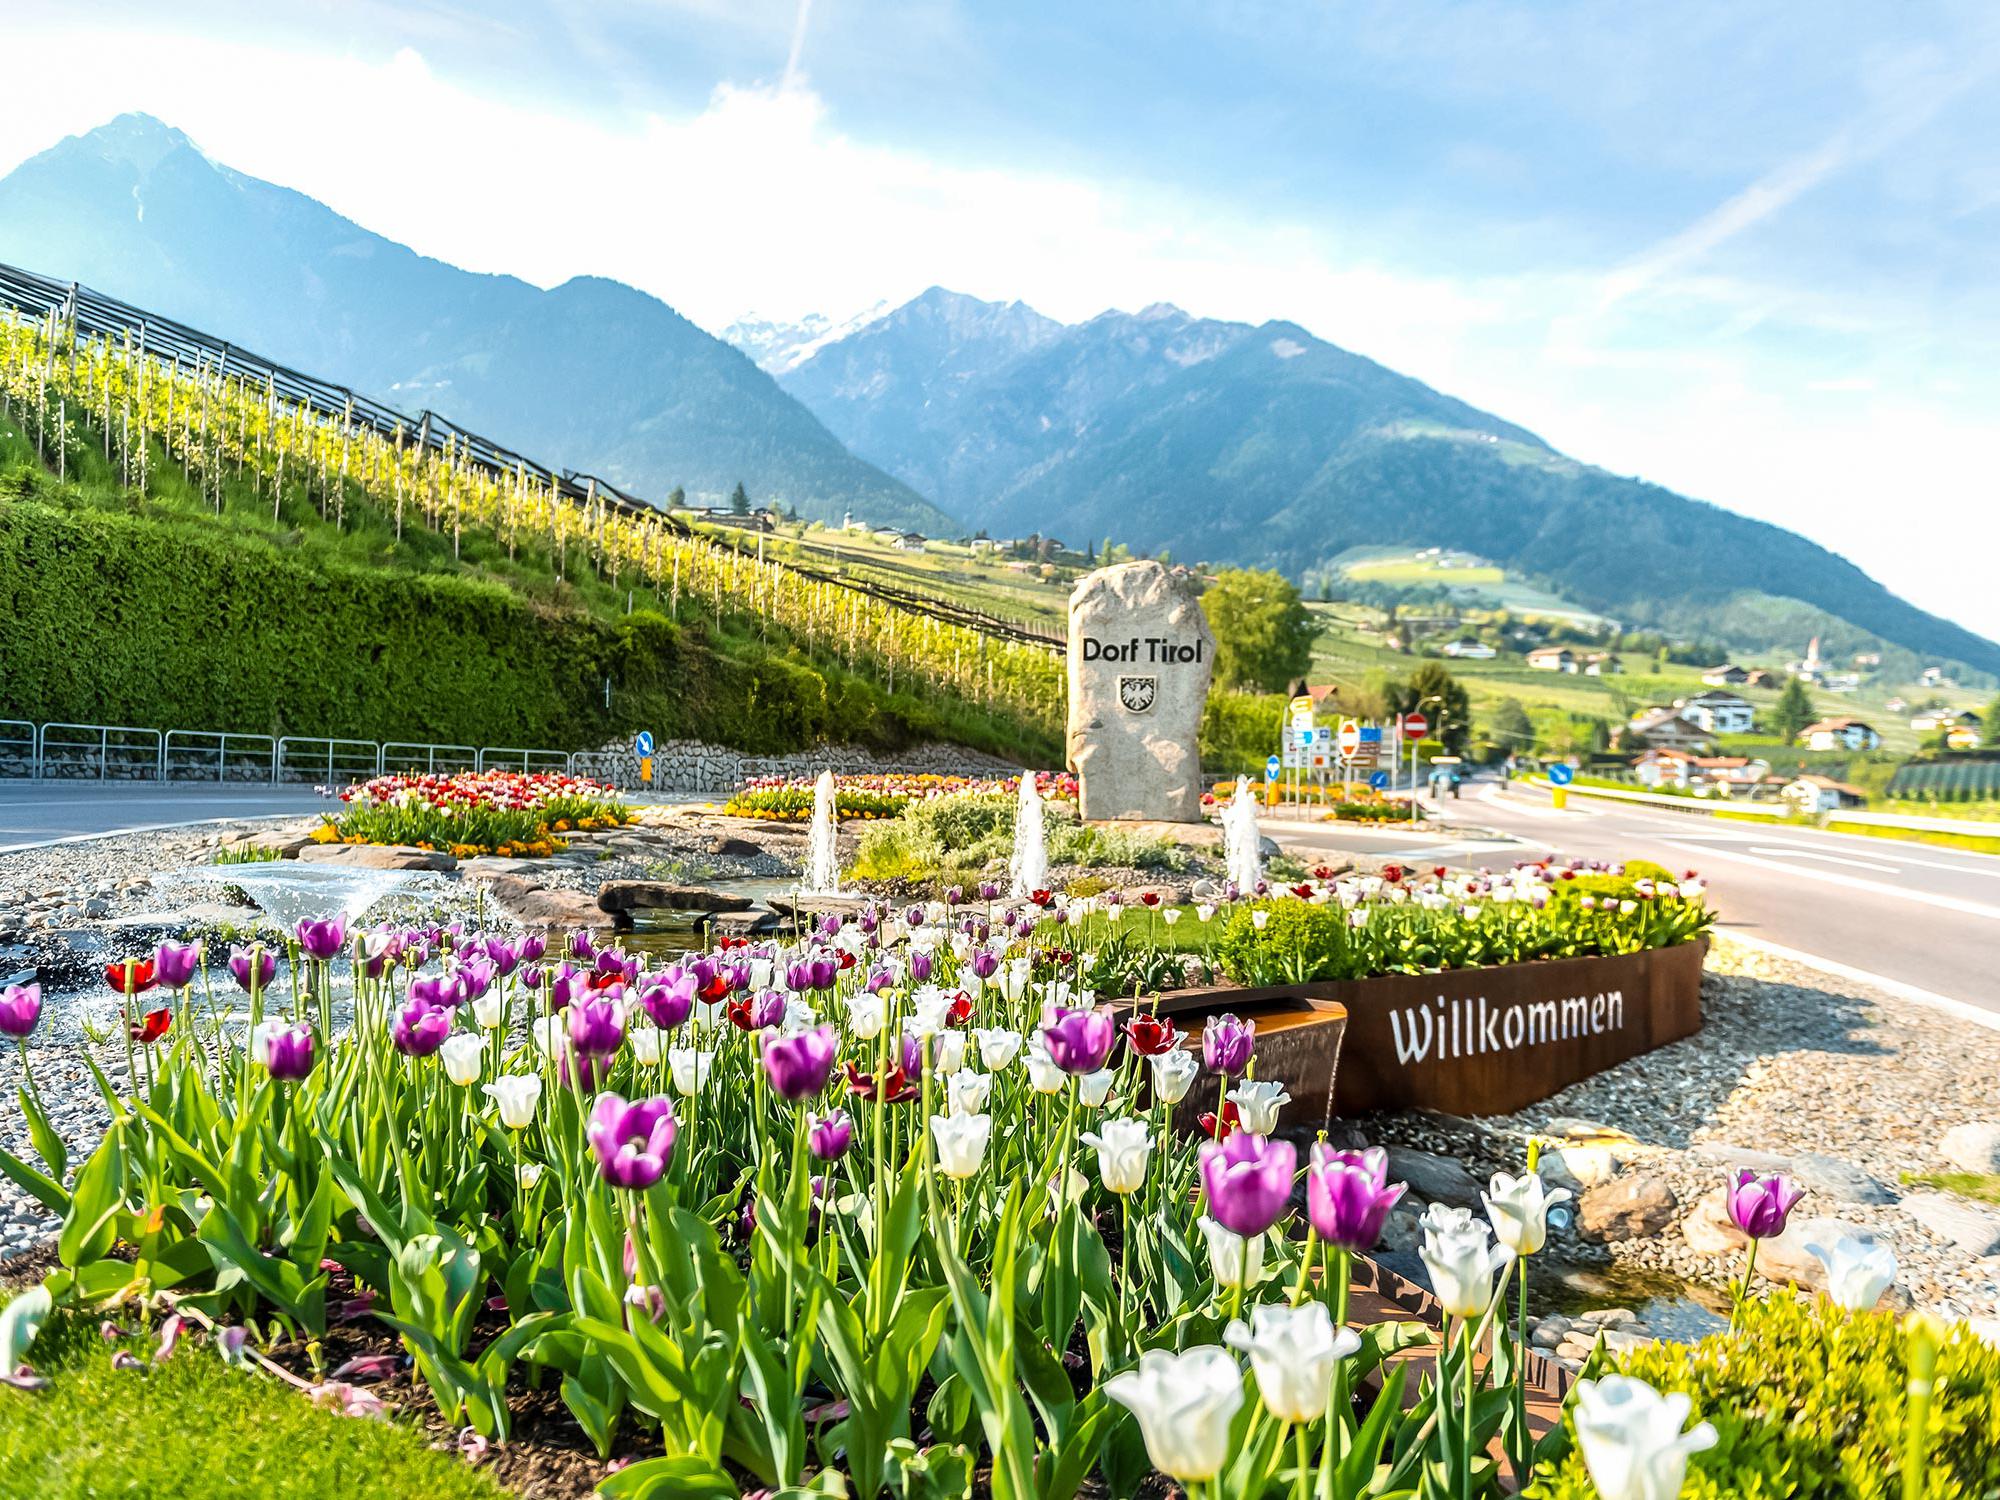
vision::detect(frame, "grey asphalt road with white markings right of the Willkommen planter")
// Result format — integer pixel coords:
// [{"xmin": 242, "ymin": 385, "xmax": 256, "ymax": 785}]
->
[{"xmin": 1264, "ymin": 782, "xmax": 2000, "ymax": 1014}]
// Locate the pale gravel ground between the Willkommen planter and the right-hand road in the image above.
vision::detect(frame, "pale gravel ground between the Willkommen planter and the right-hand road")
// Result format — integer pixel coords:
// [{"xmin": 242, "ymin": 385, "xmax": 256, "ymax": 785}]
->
[{"xmin": 1364, "ymin": 936, "xmax": 2000, "ymax": 1316}]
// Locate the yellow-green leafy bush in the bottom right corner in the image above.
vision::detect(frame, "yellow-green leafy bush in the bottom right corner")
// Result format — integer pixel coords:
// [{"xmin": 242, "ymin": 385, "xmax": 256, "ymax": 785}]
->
[{"xmin": 1524, "ymin": 1294, "xmax": 2000, "ymax": 1500}]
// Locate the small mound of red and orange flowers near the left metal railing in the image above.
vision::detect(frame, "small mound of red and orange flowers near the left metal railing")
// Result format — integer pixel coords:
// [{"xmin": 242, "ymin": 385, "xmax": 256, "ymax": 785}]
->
[{"xmin": 314, "ymin": 770, "xmax": 634, "ymax": 858}]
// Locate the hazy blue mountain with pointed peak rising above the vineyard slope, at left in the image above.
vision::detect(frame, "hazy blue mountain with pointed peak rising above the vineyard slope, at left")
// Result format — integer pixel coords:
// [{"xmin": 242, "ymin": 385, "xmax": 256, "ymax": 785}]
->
[{"xmin": 0, "ymin": 114, "xmax": 952, "ymax": 530}]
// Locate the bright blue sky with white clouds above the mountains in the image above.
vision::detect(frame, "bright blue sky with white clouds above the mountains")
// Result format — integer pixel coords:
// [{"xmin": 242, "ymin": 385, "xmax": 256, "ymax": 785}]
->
[{"xmin": 0, "ymin": 0, "xmax": 2000, "ymax": 638}]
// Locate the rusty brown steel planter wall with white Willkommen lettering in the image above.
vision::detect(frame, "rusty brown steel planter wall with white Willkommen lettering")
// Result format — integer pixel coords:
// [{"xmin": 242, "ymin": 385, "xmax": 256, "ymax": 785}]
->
[{"xmin": 1112, "ymin": 938, "xmax": 1708, "ymax": 1130}]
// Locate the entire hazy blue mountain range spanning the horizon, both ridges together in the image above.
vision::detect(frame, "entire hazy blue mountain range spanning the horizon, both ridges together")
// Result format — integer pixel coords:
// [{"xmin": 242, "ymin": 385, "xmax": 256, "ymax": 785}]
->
[{"xmin": 0, "ymin": 114, "xmax": 2000, "ymax": 674}]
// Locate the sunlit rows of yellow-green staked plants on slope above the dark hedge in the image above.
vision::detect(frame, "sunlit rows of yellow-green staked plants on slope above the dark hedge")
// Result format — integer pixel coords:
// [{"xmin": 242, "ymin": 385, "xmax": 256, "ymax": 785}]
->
[{"xmin": 0, "ymin": 274, "xmax": 1062, "ymax": 748}]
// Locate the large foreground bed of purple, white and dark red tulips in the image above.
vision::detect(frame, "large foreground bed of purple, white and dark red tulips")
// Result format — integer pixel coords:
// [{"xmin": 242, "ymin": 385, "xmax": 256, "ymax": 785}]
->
[{"xmin": 0, "ymin": 876, "xmax": 1992, "ymax": 1500}]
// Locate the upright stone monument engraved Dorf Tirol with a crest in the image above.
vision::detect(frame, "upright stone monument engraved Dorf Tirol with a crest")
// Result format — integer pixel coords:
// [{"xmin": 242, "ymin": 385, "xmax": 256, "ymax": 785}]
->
[{"xmin": 1068, "ymin": 562, "xmax": 1216, "ymax": 822}]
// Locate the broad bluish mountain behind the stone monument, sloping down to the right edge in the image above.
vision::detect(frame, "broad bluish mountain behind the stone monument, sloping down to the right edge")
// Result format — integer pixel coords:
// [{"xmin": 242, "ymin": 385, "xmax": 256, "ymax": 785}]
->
[{"xmin": 782, "ymin": 288, "xmax": 2000, "ymax": 672}]
